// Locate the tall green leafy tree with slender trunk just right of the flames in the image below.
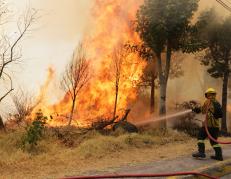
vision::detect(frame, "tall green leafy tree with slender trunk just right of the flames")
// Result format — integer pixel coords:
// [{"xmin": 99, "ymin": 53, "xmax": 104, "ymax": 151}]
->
[{"xmin": 136, "ymin": 0, "xmax": 198, "ymax": 128}]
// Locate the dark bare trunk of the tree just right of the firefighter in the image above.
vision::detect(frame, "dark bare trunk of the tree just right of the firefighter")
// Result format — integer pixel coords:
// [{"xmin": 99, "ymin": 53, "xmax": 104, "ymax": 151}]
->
[{"xmin": 221, "ymin": 71, "xmax": 229, "ymax": 132}]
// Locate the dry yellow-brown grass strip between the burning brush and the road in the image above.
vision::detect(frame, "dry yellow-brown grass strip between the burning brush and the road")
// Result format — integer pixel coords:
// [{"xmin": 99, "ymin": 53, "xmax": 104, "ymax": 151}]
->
[{"xmin": 0, "ymin": 131, "xmax": 199, "ymax": 179}]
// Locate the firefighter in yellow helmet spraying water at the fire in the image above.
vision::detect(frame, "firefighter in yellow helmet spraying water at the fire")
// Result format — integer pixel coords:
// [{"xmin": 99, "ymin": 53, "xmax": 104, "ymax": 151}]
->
[{"xmin": 192, "ymin": 88, "xmax": 223, "ymax": 161}]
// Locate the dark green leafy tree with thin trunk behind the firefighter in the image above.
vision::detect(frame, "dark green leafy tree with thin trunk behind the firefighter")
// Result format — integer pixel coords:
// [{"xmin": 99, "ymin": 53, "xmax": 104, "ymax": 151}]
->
[{"xmin": 197, "ymin": 9, "xmax": 231, "ymax": 132}]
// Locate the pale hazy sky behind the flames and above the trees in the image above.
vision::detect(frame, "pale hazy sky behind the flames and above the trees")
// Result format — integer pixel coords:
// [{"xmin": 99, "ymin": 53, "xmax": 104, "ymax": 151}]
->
[{"xmin": 4, "ymin": 0, "xmax": 231, "ymax": 95}]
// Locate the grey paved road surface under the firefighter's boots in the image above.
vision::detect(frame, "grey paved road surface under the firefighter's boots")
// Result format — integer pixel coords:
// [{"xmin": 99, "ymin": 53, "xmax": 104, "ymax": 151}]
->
[{"xmin": 92, "ymin": 145, "xmax": 231, "ymax": 179}]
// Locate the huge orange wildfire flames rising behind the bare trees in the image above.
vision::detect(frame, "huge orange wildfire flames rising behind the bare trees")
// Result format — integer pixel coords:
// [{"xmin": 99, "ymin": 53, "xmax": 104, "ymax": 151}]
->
[{"xmin": 32, "ymin": 0, "xmax": 145, "ymax": 126}]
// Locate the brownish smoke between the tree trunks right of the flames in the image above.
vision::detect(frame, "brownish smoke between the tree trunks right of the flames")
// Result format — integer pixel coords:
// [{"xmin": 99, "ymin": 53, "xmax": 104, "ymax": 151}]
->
[{"xmin": 131, "ymin": 0, "xmax": 230, "ymax": 121}]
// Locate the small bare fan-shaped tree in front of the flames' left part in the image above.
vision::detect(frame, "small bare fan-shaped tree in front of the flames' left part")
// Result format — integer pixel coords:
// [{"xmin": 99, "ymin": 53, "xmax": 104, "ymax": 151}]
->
[{"xmin": 61, "ymin": 43, "xmax": 90, "ymax": 126}]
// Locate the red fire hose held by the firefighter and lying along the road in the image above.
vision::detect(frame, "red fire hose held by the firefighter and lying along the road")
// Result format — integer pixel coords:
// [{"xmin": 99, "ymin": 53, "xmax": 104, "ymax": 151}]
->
[{"xmin": 63, "ymin": 101, "xmax": 231, "ymax": 179}]
